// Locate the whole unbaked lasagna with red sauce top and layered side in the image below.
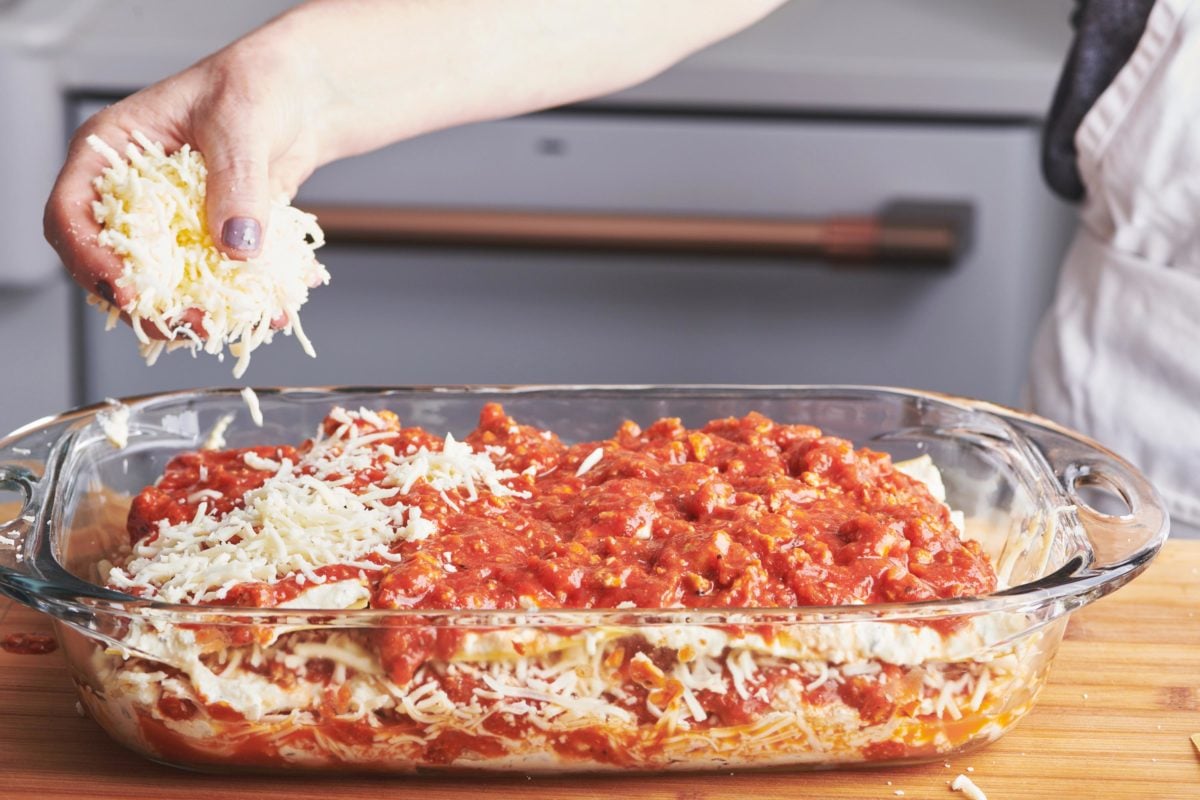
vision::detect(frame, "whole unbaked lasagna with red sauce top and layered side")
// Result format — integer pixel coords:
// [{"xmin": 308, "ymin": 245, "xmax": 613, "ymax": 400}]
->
[{"xmin": 83, "ymin": 404, "xmax": 1040, "ymax": 771}]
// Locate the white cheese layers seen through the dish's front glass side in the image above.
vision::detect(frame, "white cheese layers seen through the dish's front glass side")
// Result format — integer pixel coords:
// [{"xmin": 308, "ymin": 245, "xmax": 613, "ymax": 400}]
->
[{"xmin": 96, "ymin": 606, "xmax": 1032, "ymax": 765}]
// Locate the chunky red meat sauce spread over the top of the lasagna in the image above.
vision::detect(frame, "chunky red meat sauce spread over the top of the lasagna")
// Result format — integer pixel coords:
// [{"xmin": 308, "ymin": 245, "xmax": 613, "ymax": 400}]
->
[{"xmin": 119, "ymin": 404, "xmax": 996, "ymax": 681}]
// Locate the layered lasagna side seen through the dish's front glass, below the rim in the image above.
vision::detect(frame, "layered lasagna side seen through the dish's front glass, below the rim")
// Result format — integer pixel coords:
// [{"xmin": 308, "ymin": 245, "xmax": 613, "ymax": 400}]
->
[{"xmin": 92, "ymin": 620, "xmax": 1043, "ymax": 770}]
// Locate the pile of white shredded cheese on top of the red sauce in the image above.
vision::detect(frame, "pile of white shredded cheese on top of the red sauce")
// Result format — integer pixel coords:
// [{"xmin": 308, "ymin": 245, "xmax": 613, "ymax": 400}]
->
[{"xmin": 107, "ymin": 409, "xmax": 528, "ymax": 603}]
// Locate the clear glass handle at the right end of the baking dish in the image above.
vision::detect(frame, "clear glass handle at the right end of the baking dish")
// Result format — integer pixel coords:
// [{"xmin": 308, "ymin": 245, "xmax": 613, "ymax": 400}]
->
[{"xmin": 1006, "ymin": 414, "xmax": 1170, "ymax": 578}]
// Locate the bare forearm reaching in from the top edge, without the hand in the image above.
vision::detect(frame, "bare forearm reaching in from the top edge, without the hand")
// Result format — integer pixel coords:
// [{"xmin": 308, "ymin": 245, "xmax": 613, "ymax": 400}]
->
[{"xmin": 247, "ymin": 0, "xmax": 782, "ymax": 163}]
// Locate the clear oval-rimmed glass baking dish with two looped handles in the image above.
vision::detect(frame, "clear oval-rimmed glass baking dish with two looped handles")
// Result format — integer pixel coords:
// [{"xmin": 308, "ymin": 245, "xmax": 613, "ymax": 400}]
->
[{"xmin": 0, "ymin": 386, "xmax": 1168, "ymax": 772}]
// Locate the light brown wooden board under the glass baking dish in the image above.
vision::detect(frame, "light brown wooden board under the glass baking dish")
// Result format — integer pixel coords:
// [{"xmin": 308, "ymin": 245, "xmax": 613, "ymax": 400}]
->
[{"xmin": 0, "ymin": 541, "xmax": 1200, "ymax": 800}]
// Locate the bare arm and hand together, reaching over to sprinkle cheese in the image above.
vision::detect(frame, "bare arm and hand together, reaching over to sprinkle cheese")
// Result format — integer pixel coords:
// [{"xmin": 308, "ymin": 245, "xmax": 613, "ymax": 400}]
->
[{"xmin": 46, "ymin": 0, "xmax": 782, "ymax": 305}]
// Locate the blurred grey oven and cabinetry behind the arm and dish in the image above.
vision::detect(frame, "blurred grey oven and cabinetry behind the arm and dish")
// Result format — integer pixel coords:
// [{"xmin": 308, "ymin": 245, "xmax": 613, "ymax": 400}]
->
[{"xmin": 0, "ymin": 0, "xmax": 1073, "ymax": 431}]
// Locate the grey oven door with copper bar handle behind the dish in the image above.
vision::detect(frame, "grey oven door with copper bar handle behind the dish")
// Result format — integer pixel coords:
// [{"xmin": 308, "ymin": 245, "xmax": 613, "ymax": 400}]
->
[{"xmin": 72, "ymin": 108, "xmax": 1067, "ymax": 402}]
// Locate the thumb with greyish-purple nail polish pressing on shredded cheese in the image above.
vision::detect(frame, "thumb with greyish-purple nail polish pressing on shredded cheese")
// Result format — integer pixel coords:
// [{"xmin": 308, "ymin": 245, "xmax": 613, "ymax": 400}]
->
[{"xmin": 197, "ymin": 130, "xmax": 270, "ymax": 260}]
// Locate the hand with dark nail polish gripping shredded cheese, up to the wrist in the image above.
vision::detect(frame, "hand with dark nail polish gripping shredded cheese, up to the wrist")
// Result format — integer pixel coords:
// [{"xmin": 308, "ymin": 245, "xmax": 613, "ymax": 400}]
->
[{"xmin": 44, "ymin": 43, "xmax": 319, "ymax": 338}]
